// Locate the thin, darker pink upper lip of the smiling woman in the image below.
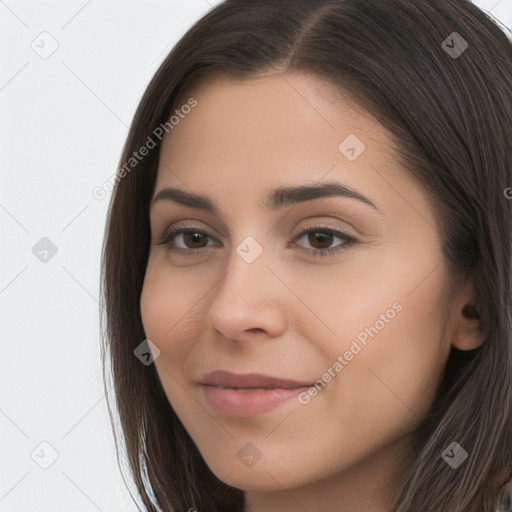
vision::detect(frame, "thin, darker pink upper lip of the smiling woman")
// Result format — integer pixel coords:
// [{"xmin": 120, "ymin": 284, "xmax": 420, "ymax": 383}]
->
[{"xmin": 200, "ymin": 370, "xmax": 311, "ymax": 389}]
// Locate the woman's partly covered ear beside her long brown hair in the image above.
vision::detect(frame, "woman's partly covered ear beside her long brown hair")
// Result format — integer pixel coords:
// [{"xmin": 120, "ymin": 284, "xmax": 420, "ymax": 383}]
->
[{"xmin": 452, "ymin": 280, "xmax": 486, "ymax": 350}]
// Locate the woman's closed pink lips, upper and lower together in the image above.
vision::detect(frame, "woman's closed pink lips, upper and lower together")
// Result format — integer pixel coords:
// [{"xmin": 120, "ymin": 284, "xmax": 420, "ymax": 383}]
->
[{"xmin": 199, "ymin": 370, "xmax": 313, "ymax": 418}]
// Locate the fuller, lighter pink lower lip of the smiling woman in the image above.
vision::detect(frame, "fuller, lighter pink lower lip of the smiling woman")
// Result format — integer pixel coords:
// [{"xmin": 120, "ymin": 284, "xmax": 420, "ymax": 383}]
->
[{"xmin": 201, "ymin": 384, "xmax": 309, "ymax": 418}]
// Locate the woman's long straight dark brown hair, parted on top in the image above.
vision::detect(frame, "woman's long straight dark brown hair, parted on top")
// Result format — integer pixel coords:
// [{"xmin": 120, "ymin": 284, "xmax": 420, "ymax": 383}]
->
[{"xmin": 101, "ymin": 0, "xmax": 512, "ymax": 512}]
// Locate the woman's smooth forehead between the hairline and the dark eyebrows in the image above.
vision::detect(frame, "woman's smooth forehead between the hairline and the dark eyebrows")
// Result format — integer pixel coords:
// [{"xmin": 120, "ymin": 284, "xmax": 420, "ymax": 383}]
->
[{"xmin": 152, "ymin": 74, "xmax": 436, "ymax": 234}]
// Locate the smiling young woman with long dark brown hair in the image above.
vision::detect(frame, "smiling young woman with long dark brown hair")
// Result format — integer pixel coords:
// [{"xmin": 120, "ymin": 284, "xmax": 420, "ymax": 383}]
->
[{"xmin": 102, "ymin": 0, "xmax": 512, "ymax": 512}]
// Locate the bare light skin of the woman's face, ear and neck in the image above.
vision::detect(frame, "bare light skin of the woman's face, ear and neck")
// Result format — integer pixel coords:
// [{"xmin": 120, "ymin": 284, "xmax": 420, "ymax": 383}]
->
[{"xmin": 140, "ymin": 73, "xmax": 482, "ymax": 512}]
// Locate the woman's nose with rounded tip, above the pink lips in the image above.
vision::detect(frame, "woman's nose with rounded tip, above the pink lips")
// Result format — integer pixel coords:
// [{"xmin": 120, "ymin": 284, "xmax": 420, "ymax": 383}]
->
[{"xmin": 208, "ymin": 245, "xmax": 290, "ymax": 341}]
